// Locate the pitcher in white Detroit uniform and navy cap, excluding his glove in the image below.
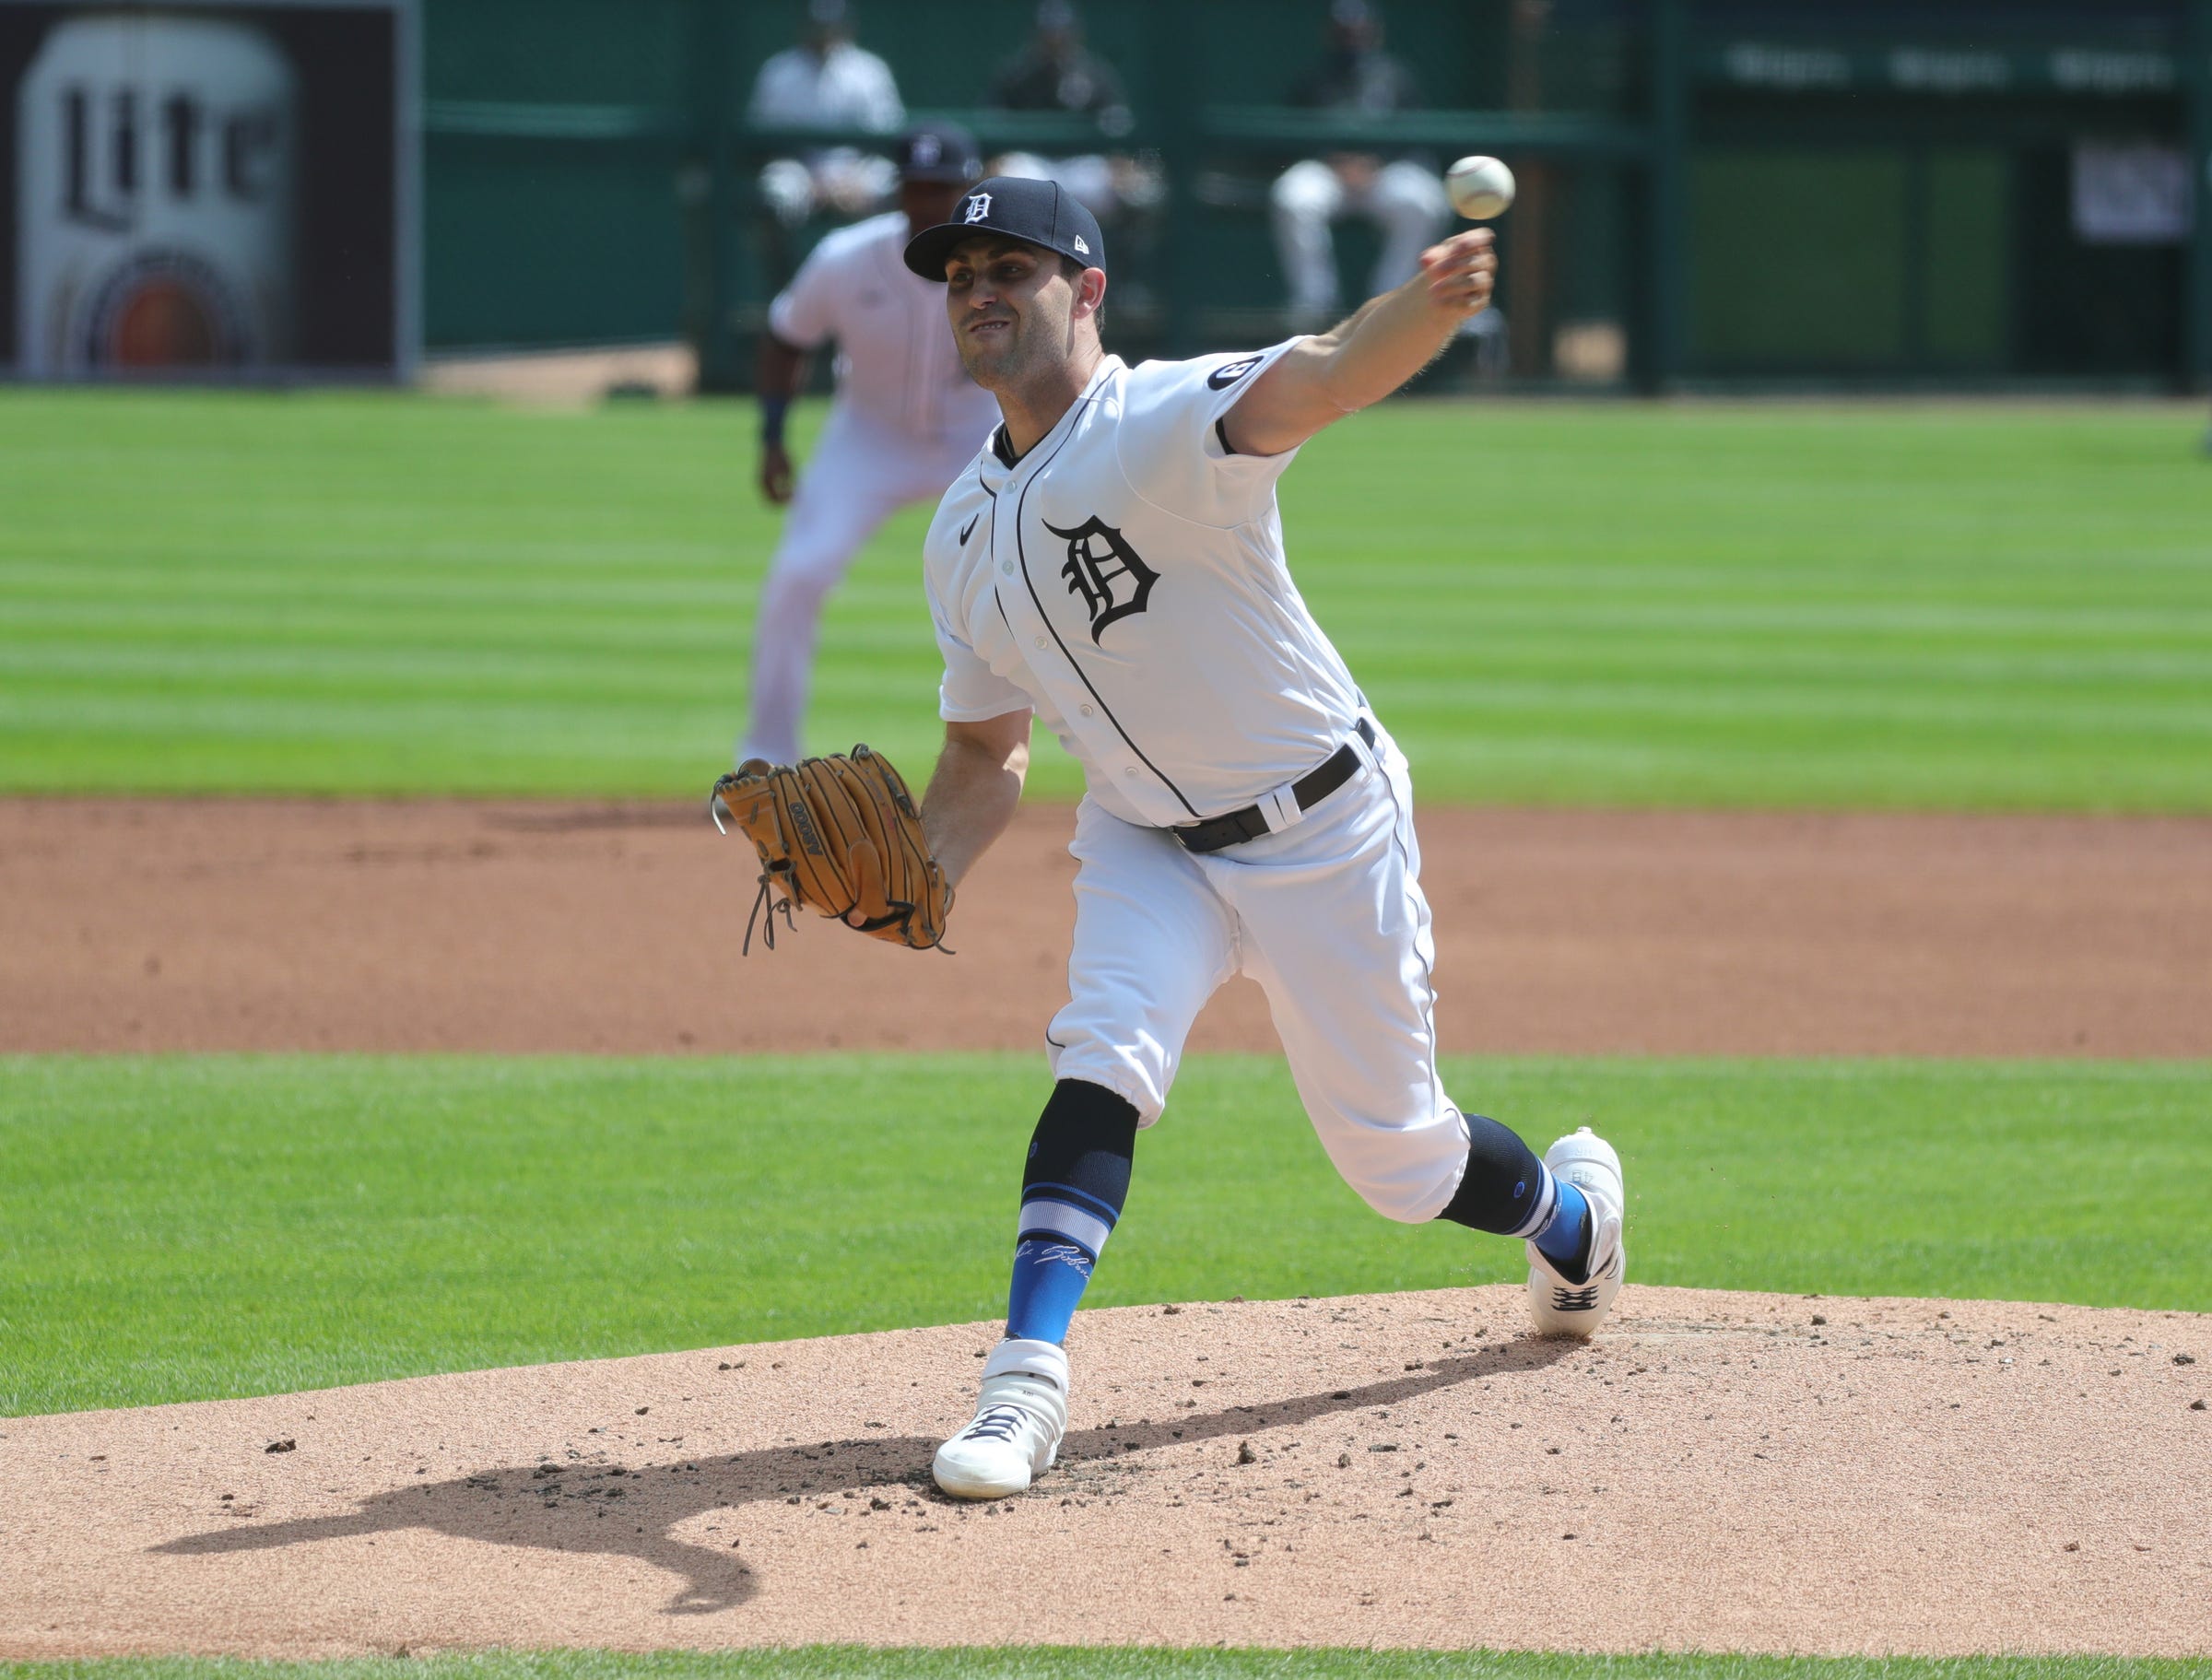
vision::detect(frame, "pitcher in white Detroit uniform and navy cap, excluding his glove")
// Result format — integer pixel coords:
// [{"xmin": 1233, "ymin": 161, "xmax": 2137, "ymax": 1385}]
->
[{"xmin": 907, "ymin": 177, "xmax": 1626, "ymax": 1498}]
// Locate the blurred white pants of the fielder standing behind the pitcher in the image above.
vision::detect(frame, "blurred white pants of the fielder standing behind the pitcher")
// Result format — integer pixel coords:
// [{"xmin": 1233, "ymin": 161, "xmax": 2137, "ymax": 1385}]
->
[{"xmin": 736, "ymin": 403, "xmax": 980, "ymax": 765}]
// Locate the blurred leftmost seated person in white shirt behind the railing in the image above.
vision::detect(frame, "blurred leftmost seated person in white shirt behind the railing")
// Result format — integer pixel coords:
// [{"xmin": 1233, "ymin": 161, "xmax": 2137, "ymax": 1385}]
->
[{"xmin": 746, "ymin": 0, "xmax": 907, "ymax": 229}]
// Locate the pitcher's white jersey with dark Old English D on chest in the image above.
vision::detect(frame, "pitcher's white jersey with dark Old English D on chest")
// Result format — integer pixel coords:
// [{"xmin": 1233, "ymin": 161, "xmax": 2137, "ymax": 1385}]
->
[{"xmin": 923, "ymin": 340, "xmax": 1360, "ymax": 827}]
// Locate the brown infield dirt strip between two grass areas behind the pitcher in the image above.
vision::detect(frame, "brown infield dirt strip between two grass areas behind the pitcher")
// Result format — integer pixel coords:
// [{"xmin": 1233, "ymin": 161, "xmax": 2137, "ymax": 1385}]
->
[{"xmin": 0, "ymin": 800, "xmax": 2212, "ymax": 1057}]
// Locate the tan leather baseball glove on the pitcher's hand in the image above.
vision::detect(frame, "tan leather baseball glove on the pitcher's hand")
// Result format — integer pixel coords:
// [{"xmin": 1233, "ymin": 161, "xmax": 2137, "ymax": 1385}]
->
[{"xmin": 708, "ymin": 747, "xmax": 953, "ymax": 950}]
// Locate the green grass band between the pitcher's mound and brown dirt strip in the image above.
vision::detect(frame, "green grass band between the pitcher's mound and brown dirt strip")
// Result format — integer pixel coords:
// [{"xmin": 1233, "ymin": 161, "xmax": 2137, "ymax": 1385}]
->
[{"xmin": 0, "ymin": 1057, "xmax": 2212, "ymax": 1413}]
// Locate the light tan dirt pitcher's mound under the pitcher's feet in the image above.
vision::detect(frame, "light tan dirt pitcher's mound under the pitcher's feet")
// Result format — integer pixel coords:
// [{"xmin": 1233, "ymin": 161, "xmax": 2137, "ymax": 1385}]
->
[{"xmin": 0, "ymin": 1286, "xmax": 2212, "ymax": 1658}]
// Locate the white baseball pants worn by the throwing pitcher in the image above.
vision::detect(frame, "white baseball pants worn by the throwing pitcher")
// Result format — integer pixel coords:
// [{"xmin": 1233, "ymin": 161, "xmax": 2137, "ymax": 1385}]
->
[{"xmin": 1046, "ymin": 730, "xmax": 1466, "ymax": 1222}]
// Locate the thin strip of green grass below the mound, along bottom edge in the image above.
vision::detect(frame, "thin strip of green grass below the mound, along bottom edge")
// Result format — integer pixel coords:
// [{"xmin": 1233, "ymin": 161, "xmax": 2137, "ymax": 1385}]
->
[{"xmin": 0, "ymin": 1645, "xmax": 2212, "ymax": 1680}]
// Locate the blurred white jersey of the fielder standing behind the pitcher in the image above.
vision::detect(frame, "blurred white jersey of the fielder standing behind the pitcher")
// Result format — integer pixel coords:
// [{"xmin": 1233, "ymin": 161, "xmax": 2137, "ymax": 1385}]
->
[{"xmin": 768, "ymin": 210, "xmax": 997, "ymax": 442}]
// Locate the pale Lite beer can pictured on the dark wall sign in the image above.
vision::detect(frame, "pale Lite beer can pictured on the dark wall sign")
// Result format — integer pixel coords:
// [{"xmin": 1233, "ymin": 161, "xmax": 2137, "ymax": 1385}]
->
[{"xmin": 16, "ymin": 11, "xmax": 299, "ymax": 378}]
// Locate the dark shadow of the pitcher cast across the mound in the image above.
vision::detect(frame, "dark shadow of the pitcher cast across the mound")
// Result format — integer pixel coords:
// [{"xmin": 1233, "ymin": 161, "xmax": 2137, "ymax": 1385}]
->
[{"xmin": 150, "ymin": 1340, "xmax": 1583, "ymax": 1615}]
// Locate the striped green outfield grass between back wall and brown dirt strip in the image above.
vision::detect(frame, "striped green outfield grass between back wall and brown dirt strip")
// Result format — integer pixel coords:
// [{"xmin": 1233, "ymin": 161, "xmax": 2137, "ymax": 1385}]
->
[{"xmin": 0, "ymin": 392, "xmax": 2212, "ymax": 811}]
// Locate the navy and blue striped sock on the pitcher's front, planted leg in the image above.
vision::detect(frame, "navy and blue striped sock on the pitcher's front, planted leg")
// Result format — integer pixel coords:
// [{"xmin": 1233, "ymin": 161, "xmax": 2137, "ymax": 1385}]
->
[{"xmin": 1006, "ymin": 1079, "xmax": 1137, "ymax": 1344}]
